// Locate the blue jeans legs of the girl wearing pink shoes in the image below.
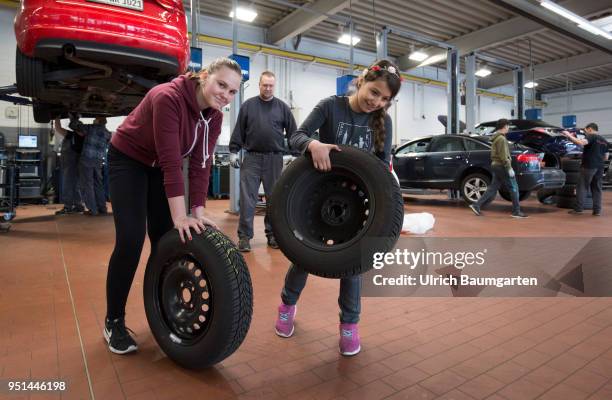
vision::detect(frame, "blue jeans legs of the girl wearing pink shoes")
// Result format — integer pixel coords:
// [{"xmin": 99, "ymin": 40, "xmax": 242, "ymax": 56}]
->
[{"xmin": 281, "ymin": 264, "xmax": 361, "ymax": 324}]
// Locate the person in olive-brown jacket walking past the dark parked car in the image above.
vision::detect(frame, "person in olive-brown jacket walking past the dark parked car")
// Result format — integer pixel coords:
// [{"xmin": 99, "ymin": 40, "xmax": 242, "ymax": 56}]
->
[{"xmin": 470, "ymin": 118, "xmax": 527, "ymax": 218}]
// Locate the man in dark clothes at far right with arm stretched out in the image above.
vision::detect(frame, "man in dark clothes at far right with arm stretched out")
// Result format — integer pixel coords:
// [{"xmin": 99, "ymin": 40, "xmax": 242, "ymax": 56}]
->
[{"xmin": 564, "ymin": 122, "xmax": 608, "ymax": 217}]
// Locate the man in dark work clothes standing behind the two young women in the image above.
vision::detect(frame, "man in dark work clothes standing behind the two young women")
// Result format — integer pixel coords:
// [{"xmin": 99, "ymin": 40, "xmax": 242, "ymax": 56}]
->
[{"xmin": 229, "ymin": 71, "xmax": 297, "ymax": 251}]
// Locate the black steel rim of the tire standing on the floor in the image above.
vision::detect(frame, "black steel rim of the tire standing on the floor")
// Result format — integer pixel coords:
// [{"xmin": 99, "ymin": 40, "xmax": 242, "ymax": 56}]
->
[{"xmin": 157, "ymin": 255, "xmax": 213, "ymax": 345}]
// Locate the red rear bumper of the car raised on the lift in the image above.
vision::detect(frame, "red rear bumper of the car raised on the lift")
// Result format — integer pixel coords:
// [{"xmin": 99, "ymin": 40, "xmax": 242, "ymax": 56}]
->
[{"xmin": 15, "ymin": 0, "xmax": 189, "ymax": 74}]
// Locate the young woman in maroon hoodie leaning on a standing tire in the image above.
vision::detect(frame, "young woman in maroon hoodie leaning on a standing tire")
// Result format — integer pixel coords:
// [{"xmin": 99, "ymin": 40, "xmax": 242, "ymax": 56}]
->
[{"xmin": 104, "ymin": 58, "xmax": 242, "ymax": 354}]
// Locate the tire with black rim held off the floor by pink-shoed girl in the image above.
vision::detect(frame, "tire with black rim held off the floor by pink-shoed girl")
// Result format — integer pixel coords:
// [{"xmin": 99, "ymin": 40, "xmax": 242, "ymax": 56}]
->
[{"xmin": 268, "ymin": 146, "xmax": 404, "ymax": 278}]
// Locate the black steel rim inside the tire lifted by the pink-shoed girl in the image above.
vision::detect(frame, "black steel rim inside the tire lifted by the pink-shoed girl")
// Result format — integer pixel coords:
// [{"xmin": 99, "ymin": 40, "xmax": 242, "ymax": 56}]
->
[{"xmin": 286, "ymin": 168, "xmax": 375, "ymax": 251}]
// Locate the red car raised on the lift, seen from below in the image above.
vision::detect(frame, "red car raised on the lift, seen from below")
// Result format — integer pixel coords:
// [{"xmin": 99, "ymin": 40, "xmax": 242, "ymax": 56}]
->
[{"xmin": 15, "ymin": 0, "xmax": 189, "ymax": 122}]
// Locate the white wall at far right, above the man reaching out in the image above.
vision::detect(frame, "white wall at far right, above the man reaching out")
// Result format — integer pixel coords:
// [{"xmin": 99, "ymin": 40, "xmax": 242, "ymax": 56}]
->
[{"xmin": 542, "ymin": 86, "xmax": 612, "ymax": 137}]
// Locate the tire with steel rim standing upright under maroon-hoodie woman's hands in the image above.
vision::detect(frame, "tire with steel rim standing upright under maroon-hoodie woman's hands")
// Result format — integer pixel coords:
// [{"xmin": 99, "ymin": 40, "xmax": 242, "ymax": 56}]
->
[{"xmin": 144, "ymin": 227, "xmax": 253, "ymax": 369}]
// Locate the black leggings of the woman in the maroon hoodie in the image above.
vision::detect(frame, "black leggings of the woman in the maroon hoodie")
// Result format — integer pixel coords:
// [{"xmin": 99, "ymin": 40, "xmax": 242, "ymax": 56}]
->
[{"xmin": 106, "ymin": 145, "xmax": 174, "ymax": 320}]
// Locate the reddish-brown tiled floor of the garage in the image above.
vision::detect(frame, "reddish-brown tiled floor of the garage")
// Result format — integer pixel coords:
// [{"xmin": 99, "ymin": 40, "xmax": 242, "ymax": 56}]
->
[{"xmin": 0, "ymin": 192, "xmax": 612, "ymax": 400}]
